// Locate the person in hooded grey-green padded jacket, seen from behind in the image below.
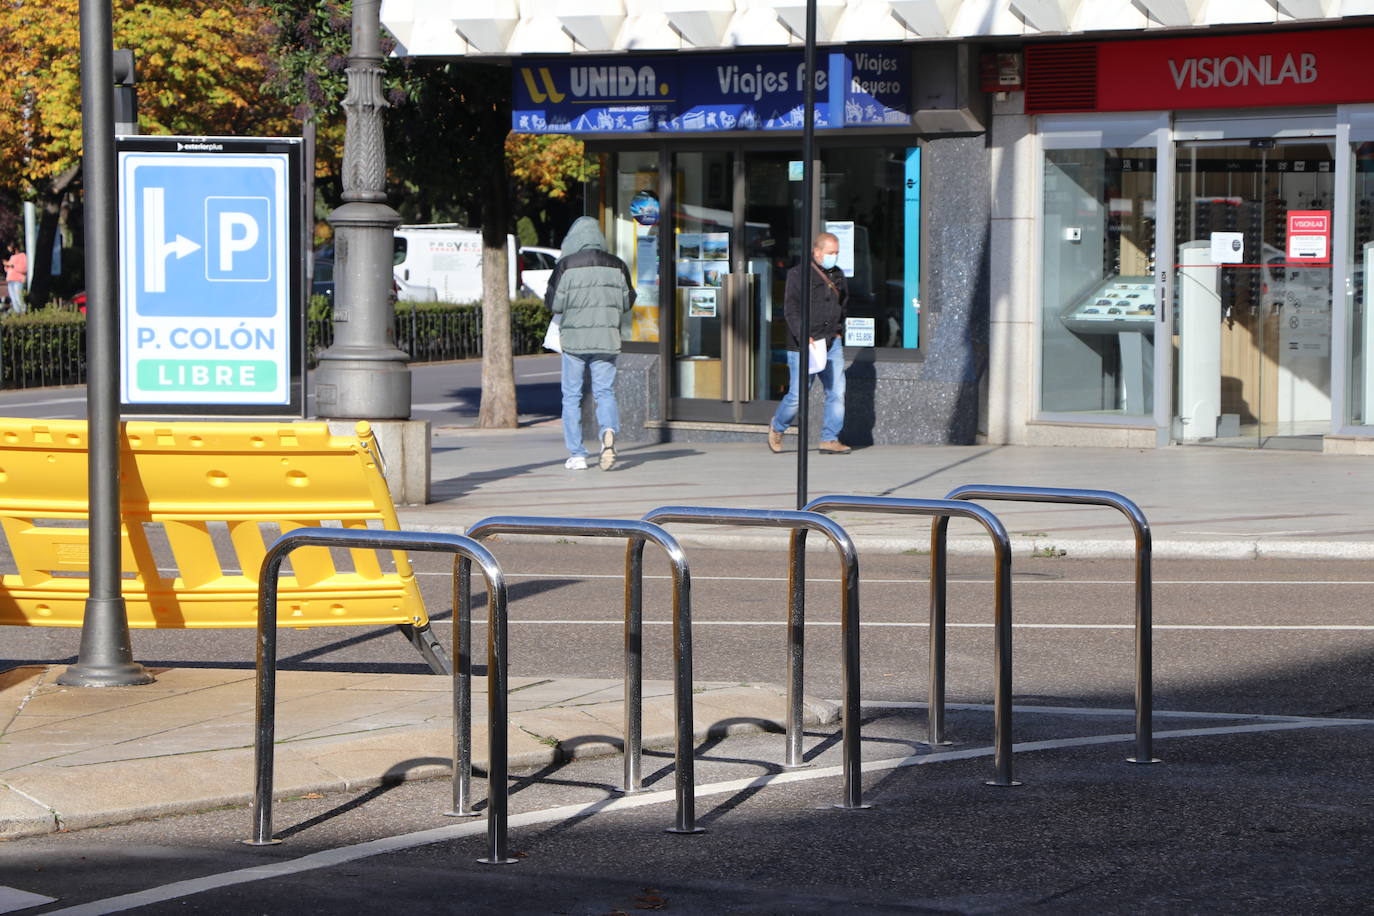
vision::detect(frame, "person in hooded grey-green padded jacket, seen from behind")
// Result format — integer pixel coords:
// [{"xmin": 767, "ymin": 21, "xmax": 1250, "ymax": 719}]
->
[{"xmin": 544, "ymin": 216, "xmax": 635, "ymax": 471}]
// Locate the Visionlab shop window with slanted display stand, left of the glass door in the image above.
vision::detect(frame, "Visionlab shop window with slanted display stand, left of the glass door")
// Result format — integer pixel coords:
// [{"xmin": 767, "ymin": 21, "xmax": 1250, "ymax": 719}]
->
[{"xmin": 1040, "ymin": 147, "xmax": 1157, "ymax": 417}]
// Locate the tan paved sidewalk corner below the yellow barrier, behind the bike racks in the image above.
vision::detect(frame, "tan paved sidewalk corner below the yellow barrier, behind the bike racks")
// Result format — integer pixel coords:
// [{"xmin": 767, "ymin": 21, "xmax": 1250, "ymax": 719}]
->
[{"xmin": 0, "ymin": 665, "xmax": 838, "ymax": 838}]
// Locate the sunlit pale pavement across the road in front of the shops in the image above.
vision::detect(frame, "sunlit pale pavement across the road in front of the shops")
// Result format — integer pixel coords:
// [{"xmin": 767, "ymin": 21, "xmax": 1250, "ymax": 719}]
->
[{"xmin": 400, "ymin": 422, "xmax": 1374, "ymax": 559}]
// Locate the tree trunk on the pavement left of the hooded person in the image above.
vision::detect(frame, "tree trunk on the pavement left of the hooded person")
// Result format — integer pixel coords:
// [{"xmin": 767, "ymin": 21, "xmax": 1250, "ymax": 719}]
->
[{"xmin": 477, "ymin": 143, "xmax": 519, "ymax": 428}]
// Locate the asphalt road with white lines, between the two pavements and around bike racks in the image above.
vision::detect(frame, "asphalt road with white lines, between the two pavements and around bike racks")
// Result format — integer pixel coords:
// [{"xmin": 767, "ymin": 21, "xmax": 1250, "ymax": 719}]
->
[{"xmin": 0, "ymin": 542, "xmax": 1374, "ymax": 913}]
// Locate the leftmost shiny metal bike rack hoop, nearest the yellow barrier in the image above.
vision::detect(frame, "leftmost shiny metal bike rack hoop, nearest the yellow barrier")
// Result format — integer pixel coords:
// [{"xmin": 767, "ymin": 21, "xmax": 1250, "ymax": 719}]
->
[{"xmin": 243, "ymin": 527, "xmax": 518, "ymax": 865}]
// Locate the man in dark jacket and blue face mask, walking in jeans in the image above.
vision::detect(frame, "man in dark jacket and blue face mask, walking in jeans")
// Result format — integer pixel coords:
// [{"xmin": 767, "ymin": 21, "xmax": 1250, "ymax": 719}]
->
[{"xmin": 768, "ymin": 232, "xmax": 851, "ymax": 455}]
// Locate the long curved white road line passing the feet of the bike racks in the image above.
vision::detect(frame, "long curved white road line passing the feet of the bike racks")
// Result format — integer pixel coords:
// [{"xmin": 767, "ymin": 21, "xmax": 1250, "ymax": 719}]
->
[{"xmin": 48, "ymin": 710, "xmax": 1374, "ymax": 916}]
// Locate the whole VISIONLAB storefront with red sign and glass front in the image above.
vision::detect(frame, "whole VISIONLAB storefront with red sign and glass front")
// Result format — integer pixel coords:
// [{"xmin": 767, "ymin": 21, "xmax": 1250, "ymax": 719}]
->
[{"xmin": 984, "ymin": 27, "xmax": 1374, "ymax": 453}]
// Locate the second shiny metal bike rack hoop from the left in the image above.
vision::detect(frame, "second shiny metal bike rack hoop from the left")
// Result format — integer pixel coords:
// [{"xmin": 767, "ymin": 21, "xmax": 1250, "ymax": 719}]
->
[{"xmin": 464, "ymin": 515, "xmax": 702, "ymax": 834}]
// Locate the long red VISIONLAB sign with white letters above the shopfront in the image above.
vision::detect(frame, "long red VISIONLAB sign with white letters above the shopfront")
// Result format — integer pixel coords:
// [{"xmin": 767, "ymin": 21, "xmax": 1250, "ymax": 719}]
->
[{"xmin": 1096, "ymin": 29, "xmax": 1374, "ymax": 111}]
